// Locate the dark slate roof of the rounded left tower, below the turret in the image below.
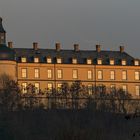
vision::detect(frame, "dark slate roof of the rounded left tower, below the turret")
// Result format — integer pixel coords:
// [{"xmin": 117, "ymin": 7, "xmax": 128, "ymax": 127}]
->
[{"xmin": 0, "ymin": 44, "xmax": 15, "ymax": 60}]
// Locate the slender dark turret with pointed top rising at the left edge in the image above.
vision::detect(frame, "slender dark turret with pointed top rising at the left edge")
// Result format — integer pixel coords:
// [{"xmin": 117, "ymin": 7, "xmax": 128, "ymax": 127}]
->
[{"xmin": 0, "ymin": 17, "xmax": 6, "ymax": 44}]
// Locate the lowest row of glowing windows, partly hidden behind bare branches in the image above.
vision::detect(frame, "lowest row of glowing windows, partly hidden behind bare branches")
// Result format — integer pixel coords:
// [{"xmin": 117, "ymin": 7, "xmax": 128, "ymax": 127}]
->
[{"xmin": 22, "ymin": 82, "xmax": 140, "ymax": 96}]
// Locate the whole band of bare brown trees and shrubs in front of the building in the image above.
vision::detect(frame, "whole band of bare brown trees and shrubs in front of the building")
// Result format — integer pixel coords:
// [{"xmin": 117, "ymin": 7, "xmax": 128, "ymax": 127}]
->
[{"xmin": 0, "ymin": 74, "xmax": 140, "ymax": 113}]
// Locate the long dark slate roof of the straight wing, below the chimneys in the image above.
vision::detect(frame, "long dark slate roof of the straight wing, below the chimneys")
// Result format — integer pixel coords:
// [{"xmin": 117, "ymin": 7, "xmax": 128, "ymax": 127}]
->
[{"xmin": 14, "ymin": 48, "xmax": 134, "ymax": 65}]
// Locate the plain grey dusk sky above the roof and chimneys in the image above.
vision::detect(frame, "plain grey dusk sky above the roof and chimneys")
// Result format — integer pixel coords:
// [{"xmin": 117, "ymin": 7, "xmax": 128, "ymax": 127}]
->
[{"xmin": 0, "ymin": 0, "xmax": 140, "ymax": 58}]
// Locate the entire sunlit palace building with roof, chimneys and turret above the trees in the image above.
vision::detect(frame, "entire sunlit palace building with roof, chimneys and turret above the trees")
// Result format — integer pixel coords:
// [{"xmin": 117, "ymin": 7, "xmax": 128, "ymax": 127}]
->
[{"xmin": 0, "ymin": 18, "xmax": 140, "ymax": 97}]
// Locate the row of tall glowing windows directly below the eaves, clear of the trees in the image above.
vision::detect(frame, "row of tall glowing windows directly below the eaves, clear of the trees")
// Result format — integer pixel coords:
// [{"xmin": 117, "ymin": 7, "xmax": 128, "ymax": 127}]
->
[{"xmin": 21, "ymin": 68, "xmax": 140, "ymax": 80}]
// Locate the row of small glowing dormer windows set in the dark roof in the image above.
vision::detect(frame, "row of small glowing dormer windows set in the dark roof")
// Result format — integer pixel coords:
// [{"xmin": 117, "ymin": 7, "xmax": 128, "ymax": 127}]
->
[{"xmin": 21, "ymin": 57, "xmax": 139, "ymax": 66}]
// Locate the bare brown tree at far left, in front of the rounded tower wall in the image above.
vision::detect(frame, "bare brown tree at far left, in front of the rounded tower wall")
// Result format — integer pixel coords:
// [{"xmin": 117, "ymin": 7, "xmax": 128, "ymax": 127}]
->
[{"xmin": 0, "ymin": 74, "xmax": 21, "ymax": 111}]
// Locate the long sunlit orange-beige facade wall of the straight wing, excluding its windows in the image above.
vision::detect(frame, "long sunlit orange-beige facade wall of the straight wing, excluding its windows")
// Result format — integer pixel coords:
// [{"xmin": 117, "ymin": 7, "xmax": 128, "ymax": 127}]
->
[{"xmin": 17, "ymin": 63, "xmax": 140, "ymax": 96}]
